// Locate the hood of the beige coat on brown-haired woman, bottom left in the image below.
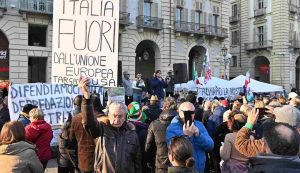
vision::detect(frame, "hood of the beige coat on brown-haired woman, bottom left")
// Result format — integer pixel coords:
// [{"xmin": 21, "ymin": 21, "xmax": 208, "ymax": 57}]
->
[{"xmin": 0, "ymin": 141, "xmax": 35, "ymax": 155}]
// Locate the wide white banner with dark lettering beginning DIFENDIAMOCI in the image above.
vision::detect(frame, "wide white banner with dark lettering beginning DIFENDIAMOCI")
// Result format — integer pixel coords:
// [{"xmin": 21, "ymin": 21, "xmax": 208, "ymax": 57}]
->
[{"xmin": 8, "ymin": 83, "xmax": 103, "ymax": 126}]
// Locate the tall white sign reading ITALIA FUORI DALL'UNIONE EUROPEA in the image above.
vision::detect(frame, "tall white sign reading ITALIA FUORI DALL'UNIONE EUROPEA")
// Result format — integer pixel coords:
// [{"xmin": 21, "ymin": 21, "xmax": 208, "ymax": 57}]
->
[{"xmin": 51, "ymin": 0, "xmax": 119, "ymax": 87}]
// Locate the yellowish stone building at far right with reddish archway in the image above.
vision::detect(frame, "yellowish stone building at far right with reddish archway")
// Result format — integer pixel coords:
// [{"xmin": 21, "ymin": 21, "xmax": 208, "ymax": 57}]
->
[{"xmin": 229, "ymin": 0, "xmax": 300, "ymax": 91}]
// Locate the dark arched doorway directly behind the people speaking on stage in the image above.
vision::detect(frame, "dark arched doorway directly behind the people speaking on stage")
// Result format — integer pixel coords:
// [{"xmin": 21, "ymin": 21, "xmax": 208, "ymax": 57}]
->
[{"xmin": 135, "ymin": 40, "xmax": 160, "ymax": 92}]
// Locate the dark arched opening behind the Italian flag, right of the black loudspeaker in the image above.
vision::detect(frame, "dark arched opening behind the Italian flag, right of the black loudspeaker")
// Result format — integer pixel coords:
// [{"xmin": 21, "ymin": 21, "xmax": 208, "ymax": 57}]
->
[{"xmin": 188, "ymin": 46, "xmax": 206, "ymax": 80}]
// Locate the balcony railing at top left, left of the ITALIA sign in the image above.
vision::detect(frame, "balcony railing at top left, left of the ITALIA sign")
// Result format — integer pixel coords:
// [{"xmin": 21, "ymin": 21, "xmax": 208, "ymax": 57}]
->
[{"xmin": 19, "ymin": 0, "xmax": 53, "ymax": 14}]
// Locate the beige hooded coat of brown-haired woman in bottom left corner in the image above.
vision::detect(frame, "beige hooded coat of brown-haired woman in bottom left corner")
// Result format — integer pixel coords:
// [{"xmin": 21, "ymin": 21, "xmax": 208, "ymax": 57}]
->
[{"xmin": 0, "ymin": 141, "xmax": 44, "ymax": 173}]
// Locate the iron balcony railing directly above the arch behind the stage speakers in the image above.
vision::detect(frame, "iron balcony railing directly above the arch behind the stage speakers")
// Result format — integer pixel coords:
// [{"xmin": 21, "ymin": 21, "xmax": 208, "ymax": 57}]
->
[{"xmin": 136, "ymin": 16, "xmax": 163, "ymax": 29}]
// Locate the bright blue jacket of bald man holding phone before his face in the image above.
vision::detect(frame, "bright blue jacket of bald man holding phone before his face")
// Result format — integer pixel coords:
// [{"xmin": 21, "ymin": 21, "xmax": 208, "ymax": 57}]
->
[{"xmin": 166, "ymin": 116, "xmax": 214, "ymax": 172}]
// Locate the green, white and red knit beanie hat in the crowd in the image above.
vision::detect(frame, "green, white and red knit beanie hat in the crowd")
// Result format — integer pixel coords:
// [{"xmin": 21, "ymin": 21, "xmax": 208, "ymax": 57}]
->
[{"xmin": 127, "ymin": 102, "xmax": 148, "ymax": 123}]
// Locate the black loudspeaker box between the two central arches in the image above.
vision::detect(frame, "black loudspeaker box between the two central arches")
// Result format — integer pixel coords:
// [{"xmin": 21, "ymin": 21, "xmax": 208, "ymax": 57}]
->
[{"xmin": 173, "ymin": 63, "xmax": 188, "ymax": 84}]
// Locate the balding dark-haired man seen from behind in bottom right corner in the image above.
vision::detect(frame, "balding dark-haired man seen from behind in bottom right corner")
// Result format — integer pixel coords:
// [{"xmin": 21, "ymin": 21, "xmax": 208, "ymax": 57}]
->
[{"xmin": 249, "ymin": 123, "xmax": 300, "ymax": 173}]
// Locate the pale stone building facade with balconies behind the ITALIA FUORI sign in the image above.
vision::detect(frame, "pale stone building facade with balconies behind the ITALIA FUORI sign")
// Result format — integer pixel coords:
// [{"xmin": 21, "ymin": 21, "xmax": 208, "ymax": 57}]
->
[{"xmin": 0, "ymin": 0, "xmax": 230, "ymax": 87}]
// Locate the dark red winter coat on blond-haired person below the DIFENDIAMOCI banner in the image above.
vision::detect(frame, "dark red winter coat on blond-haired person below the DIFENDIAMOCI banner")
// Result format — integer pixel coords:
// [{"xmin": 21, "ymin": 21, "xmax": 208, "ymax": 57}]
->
[{"xmin": 25, "ymin": 120, "xmax": 53, "ymax": 162}]
